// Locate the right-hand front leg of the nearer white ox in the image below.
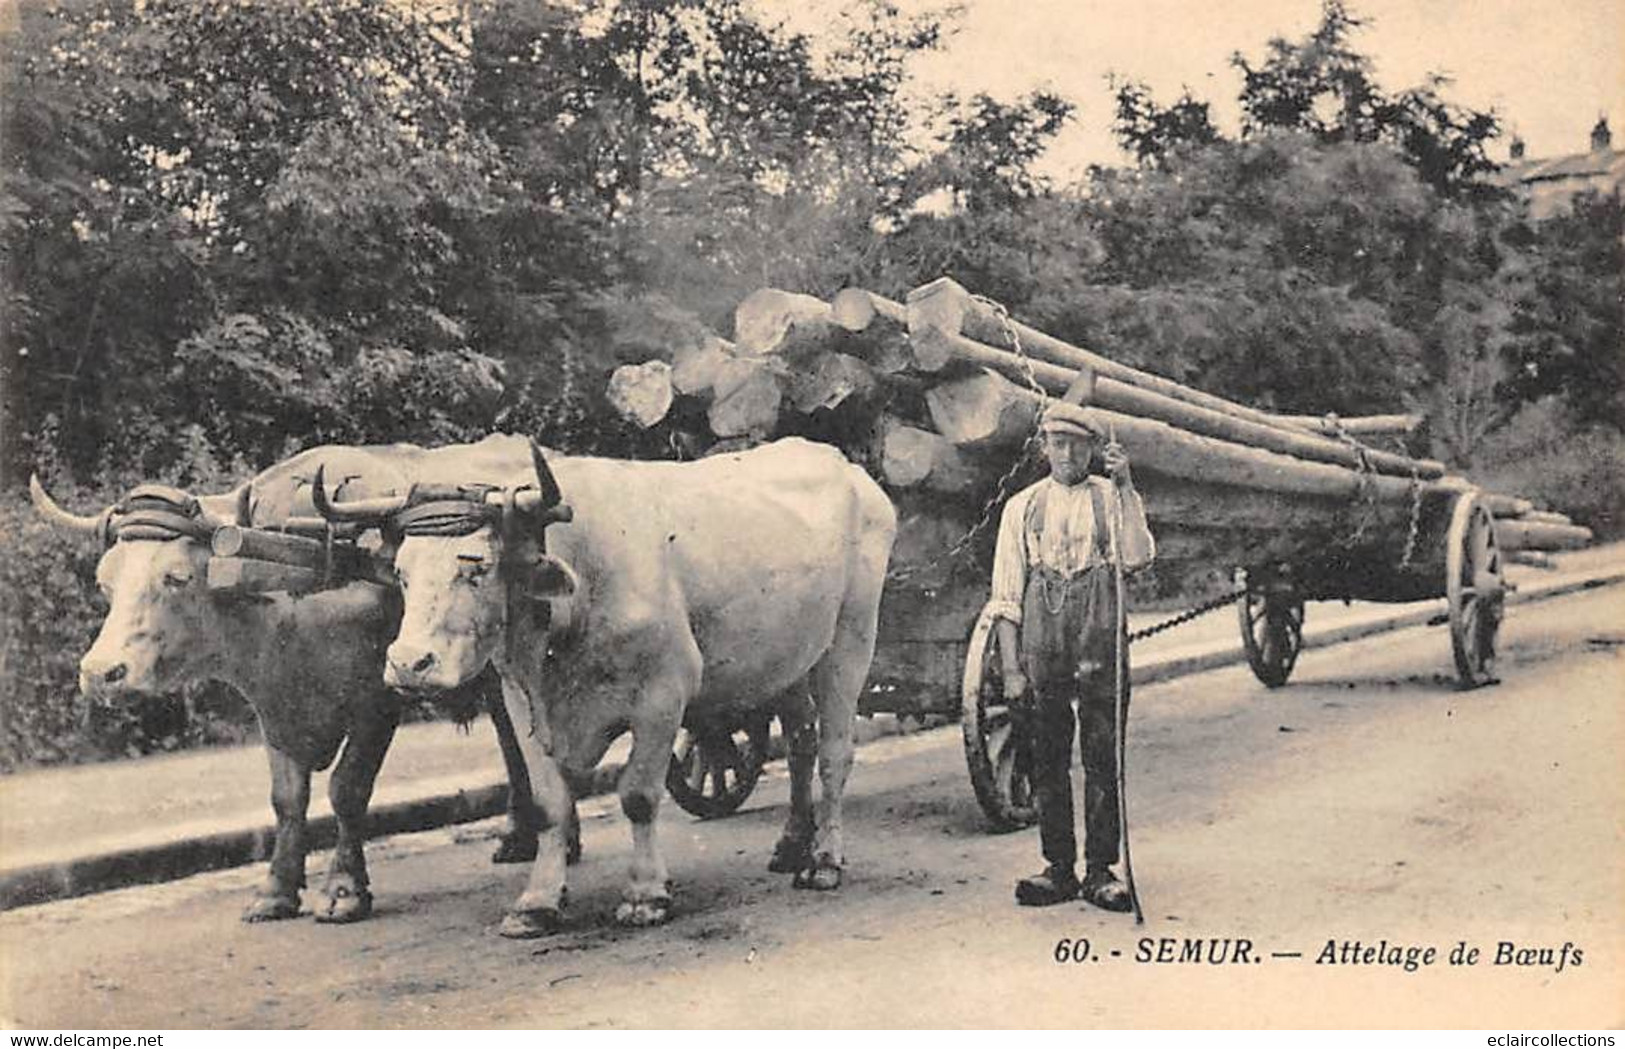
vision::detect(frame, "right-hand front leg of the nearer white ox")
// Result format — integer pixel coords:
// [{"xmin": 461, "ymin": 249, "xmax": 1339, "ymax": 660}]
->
[{"xmin": 614, "ymin": 701, "xmax": 683, "ymax": 926}]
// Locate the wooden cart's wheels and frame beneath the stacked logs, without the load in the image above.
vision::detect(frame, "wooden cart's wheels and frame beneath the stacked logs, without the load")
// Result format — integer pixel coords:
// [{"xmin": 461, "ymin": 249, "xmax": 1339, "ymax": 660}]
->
[{"xmin": 668, "ymin": 471, "xmax": 1506, "ymax": 830}]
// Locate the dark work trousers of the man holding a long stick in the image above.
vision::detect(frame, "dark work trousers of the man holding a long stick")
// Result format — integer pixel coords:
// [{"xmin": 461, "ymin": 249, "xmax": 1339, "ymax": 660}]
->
[{"xmin": 1021, "ymin": 565, "xmax": 1128, "ymax": 870}]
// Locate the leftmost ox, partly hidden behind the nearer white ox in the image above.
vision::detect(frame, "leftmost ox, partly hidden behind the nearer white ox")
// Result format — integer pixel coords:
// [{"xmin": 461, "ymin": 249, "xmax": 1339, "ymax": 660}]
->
[{"xmin": 31, "ymin": 440, "xmax": 552, "ymax": 922}]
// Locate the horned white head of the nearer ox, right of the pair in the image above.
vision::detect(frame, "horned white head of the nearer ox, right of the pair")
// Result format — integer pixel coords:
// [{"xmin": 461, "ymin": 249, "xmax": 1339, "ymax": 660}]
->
[{"xmin": 315, "ymin": 442, "xmax": 575, "ymax": 692}]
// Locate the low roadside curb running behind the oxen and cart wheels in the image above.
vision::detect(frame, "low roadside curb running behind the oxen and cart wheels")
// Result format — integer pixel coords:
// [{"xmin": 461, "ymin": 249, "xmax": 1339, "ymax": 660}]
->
[{"xmin": 0, "ymin": 565, "xmax": 1625, "ymax": 911}]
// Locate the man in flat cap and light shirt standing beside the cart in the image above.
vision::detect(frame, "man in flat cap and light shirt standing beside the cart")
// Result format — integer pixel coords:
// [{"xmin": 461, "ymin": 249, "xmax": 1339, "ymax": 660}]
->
[{"xmin": 988, "ymin": 404, "xmax": 1155, "ymax": 911}]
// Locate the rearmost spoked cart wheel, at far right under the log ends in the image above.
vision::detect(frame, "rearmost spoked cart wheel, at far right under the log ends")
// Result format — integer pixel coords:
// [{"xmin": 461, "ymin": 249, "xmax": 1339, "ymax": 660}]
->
[{"xmin": 1445, "ymin": 492, "xmax": 1506, "ymax": 689}]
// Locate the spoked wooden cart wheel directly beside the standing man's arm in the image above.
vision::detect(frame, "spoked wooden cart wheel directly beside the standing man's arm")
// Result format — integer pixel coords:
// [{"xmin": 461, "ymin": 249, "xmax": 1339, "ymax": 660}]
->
[{"xmin": 960, "ymin": 611, "xmax": 1038, "ymax": 830}]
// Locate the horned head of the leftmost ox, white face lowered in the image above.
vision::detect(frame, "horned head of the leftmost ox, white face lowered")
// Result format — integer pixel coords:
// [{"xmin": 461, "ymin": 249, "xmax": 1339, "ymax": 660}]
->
[{"xmin": 29, "ymin": 477, "xmax": 249, "ymax": 698}]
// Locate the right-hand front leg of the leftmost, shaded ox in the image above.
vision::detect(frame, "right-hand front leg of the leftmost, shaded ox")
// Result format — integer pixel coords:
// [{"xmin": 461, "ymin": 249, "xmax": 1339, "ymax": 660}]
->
[{"xmin": 315, "ymin": 711, "xmax": 400, "ymax": 924}]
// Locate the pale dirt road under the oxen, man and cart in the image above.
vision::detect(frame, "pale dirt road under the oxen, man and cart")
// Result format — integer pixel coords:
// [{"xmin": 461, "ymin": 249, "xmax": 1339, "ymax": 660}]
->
[{"xmin": 0, "ymin": 586, "xmax": 1625, "ymax": 1028}]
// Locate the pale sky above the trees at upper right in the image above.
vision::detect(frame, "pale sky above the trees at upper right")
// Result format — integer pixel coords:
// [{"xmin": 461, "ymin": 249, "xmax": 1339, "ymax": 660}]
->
[{"xmin": 761, "ymin": 0, "xmax": 1625, "ymax": 177}]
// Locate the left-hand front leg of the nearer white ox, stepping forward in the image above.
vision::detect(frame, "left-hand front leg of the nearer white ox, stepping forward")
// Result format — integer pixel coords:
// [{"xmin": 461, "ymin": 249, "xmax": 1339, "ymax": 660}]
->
[{"xmin": 497, "ymin": 679, "xmax": 575, "ymax": 940}]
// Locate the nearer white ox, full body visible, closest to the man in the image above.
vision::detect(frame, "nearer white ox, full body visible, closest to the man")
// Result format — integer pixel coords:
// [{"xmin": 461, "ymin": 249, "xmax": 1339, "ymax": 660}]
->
[{"xmin": 317, "ymin": 438, "xmax": 897, "ymax": 937}]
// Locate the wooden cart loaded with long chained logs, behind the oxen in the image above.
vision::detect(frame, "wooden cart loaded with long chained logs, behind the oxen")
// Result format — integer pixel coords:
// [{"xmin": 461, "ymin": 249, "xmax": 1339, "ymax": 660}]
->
[{"xmin": 630, "ymin": 279, "xmax": 1591, "ymax": 828}]
